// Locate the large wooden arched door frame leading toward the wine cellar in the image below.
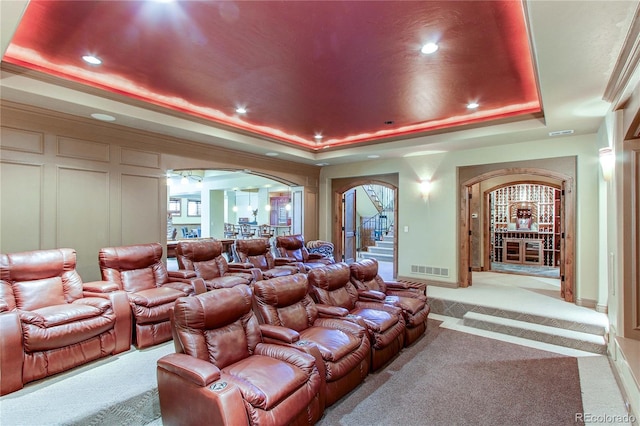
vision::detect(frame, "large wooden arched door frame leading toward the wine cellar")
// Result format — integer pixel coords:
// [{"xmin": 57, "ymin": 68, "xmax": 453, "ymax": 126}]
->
[{"xmin": 458, "ymin": 167, "xmax": 576, "ymax": 303}]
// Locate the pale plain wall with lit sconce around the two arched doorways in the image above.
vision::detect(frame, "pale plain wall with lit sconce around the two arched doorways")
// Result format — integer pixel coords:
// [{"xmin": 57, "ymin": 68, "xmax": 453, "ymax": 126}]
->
[{"xmin": 319, "ymin": 134, "xmax": 599, "ymax": 301}]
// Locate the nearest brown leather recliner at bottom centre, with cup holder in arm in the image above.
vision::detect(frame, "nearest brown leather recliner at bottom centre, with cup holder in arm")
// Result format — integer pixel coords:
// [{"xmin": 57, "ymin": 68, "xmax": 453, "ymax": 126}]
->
[{"xmin": 157, "ymin": 285, "xmax": 323, "ymax": 426}]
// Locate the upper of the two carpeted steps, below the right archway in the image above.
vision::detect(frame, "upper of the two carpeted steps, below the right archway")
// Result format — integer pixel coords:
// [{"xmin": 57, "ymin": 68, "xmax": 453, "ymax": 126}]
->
[{"xmin": 429, "ymin": 297, "xmax": 608, "ymax": 336}]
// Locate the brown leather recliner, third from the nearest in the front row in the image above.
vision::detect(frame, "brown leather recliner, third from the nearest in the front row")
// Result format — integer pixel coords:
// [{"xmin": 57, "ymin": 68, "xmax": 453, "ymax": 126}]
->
[{"xmin": 308, "ymin": 262, "xmax": 406, "ymax": 371}]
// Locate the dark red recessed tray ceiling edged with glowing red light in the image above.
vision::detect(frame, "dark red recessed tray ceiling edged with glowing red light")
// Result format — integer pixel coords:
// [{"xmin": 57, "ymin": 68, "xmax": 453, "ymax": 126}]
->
[{"xmin": 3, "ymin": 0, "xmax": 542, "ymax": 151}]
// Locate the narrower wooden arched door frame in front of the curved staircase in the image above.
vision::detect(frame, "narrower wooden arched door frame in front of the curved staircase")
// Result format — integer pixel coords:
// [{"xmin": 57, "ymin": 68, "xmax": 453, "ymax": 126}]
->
[{"xmin": 331, "ymin": 174, "xmax": 398, "ymax": 277}]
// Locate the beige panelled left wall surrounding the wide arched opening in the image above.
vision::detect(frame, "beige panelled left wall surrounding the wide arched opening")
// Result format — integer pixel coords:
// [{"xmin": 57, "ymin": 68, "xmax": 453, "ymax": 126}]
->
[{"xmin": 0, "ymin": 103, "xmax": 319, "ymax": 281}]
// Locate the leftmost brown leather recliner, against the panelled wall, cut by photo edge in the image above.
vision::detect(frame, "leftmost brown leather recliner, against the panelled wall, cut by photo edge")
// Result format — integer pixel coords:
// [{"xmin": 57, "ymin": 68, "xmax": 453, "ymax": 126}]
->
[{"xmin": 0, "ymin": 248, "xmax": 131, "ymax": 395}]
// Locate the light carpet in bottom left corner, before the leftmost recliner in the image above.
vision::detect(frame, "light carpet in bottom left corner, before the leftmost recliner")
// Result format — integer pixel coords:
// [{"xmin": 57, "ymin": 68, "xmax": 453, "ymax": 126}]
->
[{"xmin": 0, "ymin": 341, "xmax": 175, "ymax": 426}]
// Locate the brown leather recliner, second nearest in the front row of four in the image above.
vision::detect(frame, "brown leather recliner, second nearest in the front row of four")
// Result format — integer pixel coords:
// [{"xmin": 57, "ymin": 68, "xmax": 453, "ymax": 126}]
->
[{"xmin": 254, "ymin": 274, "xmax": 371, "ymax": 406}]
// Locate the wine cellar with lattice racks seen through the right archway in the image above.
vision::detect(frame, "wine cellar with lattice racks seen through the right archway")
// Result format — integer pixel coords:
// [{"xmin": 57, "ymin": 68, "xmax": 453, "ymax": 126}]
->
[{"xmin": 471, "ymin": 176, "xmax": 562, "ymax": 278}]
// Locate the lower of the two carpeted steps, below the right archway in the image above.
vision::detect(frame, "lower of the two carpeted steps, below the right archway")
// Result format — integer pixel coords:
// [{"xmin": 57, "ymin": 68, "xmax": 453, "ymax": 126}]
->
[{"xmin": 463, "ymin": 312, "xmax": 607, "ymax": 354}]
